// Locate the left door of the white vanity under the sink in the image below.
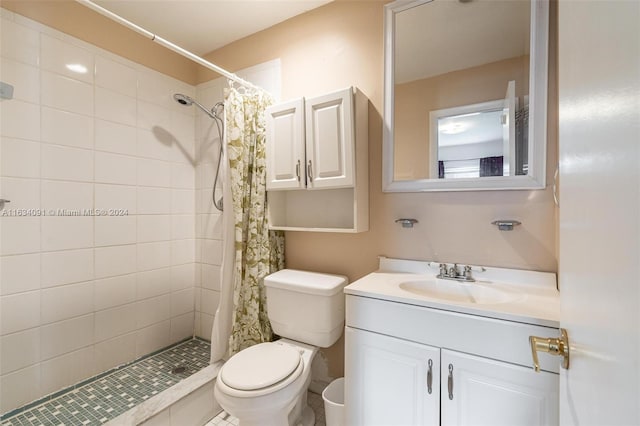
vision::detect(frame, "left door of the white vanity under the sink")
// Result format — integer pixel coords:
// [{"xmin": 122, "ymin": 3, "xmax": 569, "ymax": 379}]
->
[{"xmin": 345, "ymin": 327, "xmax": 440, "ymax": 426}]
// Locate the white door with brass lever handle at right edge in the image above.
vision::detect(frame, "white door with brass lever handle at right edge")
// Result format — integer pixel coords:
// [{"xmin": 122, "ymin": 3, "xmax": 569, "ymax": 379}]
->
[{"xmin": 558, "ymin": 0, "xmax": 640, "ymax": 425}]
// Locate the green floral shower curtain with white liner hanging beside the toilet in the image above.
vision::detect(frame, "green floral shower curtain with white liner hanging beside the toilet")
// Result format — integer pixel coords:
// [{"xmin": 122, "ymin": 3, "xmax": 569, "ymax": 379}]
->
[{"xmin": 212, "ymin": 87, "xmax": 284, "ymax": 362}]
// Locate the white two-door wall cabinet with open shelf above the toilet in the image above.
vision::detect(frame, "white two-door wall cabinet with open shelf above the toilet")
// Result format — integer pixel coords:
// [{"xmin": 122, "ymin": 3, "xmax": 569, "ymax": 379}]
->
[{"xmin": 266, "ymin": 87, "xmax": 369, "ymax": 232}]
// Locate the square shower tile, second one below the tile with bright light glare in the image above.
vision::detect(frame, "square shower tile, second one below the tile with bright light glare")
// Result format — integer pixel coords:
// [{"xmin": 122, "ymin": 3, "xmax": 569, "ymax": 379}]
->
[{"xmin": 42, "ymin": 107, "xmax": 93, "ymax": 149}]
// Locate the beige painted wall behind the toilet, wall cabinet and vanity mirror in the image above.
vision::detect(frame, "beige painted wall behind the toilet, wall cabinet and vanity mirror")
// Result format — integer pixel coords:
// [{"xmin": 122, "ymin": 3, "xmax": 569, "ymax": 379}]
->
[{"xmin": 199, "ymin": 1, "xmax": 557, "ymax": 376}]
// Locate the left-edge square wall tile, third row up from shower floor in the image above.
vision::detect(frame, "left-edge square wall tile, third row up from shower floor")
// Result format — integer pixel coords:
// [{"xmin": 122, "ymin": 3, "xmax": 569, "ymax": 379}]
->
[{"xmin": 0, "ymin": 291, "xmax": 40, "ymax": 335}]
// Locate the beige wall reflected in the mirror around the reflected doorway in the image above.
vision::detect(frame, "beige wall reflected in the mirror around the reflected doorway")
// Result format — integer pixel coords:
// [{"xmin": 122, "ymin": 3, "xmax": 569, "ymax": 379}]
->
[{"xmin": 393, "ymin": 56, "xmax": 529, "ymax": 180}]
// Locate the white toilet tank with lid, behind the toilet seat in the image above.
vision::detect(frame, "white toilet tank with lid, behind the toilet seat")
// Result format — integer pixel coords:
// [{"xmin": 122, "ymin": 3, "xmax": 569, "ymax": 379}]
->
[{"xmin": 264, "ymin": 269, "xmax": 347, "ymax": 348}]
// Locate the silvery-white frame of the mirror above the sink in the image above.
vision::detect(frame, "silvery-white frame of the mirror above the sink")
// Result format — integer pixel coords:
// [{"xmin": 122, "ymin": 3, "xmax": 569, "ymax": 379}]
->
[{"xmin": 382, "ymin": 0, "xmax": 549, "ymax": 192}]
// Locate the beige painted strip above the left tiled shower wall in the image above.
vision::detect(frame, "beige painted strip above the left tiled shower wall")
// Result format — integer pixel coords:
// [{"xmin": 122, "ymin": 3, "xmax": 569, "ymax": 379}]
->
[{"xmin": 0, "ymin": 0, "xmax": 200, "ymax": 85}]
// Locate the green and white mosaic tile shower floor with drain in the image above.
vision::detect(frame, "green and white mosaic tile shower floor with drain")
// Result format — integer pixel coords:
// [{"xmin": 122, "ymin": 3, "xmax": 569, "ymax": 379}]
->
[{"xmin": 0, "ymin": 339, "xmax": 210, "ymax": 426}]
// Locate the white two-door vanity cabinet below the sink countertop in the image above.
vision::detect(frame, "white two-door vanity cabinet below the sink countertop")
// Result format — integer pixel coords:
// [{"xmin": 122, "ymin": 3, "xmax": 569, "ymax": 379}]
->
[{"xmin": 345, "ymin": 294, "xmax": 559, "ymax": 426}]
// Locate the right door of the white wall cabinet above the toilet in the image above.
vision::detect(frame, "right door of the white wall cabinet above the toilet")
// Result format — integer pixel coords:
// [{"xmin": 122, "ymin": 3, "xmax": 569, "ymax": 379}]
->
[{"xmin": 305, "ymin": 88, "xmax": 355, "ymax": 189}]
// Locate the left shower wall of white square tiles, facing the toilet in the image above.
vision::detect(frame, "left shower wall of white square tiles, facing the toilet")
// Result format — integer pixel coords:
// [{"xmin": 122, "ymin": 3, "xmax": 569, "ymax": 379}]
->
[{"xmin": 0, "ymin": 9, "xmax": 199, "ymax": 413}]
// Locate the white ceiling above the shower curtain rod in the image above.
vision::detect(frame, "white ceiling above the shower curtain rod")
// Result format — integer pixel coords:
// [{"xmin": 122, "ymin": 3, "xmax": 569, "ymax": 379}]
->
[{"xmin": 94, "ymin": 0, "xmax": 332, "ymax": 56}]
